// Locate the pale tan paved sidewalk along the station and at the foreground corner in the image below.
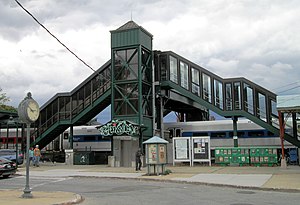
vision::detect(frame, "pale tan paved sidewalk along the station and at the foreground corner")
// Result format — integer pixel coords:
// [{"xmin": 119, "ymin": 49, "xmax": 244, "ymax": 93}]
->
[{"xmin": 0, "ymin": 163, "xmax": 300, "ymax": 205}]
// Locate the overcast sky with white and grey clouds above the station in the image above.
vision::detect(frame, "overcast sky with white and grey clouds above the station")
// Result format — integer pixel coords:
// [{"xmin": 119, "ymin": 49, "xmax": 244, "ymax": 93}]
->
[{"xmin": 0, "ymin": 0, "xmax": 300, "ymax": 121}]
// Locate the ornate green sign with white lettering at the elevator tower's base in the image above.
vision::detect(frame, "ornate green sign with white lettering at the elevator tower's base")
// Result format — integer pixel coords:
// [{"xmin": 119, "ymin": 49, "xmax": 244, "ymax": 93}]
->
[{"xmin": 97, "ymin": 120, "xmax": 139, "ymax": 136}]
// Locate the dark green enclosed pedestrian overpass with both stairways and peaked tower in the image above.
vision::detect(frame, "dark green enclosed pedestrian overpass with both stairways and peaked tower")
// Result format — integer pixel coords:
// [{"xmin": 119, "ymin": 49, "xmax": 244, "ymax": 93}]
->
[{"xmin": 28, "ymin": 21, "xmax": 300, "ymax": 148}]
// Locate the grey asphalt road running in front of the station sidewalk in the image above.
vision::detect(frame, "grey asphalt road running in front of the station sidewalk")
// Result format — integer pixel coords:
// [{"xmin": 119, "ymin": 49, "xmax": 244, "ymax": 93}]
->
[{"xmin": 0, "ymin": 176, "xmax": 300, "ymax": 205}]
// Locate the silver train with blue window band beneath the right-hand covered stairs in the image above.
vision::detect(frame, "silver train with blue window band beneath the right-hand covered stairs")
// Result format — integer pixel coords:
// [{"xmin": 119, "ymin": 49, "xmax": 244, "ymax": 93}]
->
[{"xmin": 164, "ymin": 119, "xmax": 295, "ymax": 150}]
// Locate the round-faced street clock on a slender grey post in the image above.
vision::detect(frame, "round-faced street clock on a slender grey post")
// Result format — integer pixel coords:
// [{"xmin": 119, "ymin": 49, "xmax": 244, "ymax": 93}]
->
[{"xmin": 18, "ymin": 92, "xmax": 40, "ymax": 198}]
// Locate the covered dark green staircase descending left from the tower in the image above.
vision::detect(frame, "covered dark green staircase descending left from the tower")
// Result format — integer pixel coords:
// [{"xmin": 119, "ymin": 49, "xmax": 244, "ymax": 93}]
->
[{"xmin": 32, "ymin": 61, "xmax": 111, "ymax": 148}]
